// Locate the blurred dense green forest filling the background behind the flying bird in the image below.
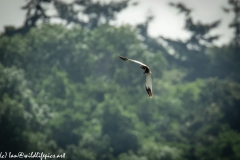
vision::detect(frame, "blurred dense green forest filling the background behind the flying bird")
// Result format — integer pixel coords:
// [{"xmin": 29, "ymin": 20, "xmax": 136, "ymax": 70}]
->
[{"xmin": 0, "ymin": 0, "xmax": 240, "ymax": 160}]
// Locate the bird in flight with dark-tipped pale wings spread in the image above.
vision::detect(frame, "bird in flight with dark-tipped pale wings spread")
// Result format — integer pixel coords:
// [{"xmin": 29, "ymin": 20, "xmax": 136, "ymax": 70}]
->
[{"xmin": 119, "ymin": 56, "xmax": 153, "ymax": 98}]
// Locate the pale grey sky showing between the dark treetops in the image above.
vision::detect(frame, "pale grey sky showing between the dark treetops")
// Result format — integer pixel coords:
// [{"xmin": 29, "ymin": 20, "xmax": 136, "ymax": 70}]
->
[{"xmin": 0, "ymin": 0, "xmax": 233, "ymax": 45}]
